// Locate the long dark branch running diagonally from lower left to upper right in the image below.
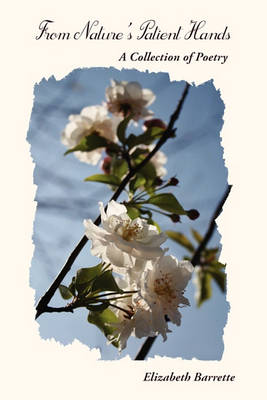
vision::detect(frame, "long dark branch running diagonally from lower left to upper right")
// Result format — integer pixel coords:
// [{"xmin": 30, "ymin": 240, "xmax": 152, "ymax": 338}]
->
[{"xmin": 35, "ymin": 83, "xmax": 190, "ymax": 319}]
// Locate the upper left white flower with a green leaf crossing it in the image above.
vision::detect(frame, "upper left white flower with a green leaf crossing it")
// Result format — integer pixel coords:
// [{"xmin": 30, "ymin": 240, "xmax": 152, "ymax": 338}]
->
[{"xmin": 61, "ymin": 106, "xmax": 121, "ymax": 165}]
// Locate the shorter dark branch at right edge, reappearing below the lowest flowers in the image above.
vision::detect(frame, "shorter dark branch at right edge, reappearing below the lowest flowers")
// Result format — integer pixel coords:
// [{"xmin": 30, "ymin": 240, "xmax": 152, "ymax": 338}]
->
[{"xmin": 135, "ymin": 185, "xmax": 232, "ymax": 360}]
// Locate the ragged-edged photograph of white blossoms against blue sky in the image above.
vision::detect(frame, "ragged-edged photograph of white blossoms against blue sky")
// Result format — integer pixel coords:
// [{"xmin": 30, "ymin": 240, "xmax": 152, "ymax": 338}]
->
[{"xmin": 27, "ymin": 67, "xmax": 231, "ymax": 361}]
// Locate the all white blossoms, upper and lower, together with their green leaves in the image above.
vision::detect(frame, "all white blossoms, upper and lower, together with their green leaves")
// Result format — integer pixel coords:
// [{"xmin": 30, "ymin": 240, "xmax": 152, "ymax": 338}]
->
[{"xmin": 61, "ymin": 80, "xmax": 197, "ymax": 350}]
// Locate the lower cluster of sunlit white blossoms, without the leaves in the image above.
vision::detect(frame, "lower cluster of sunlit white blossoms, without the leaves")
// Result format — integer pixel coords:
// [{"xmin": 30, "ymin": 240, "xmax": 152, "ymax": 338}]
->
[{"xmin": 84, "ymin": 200, "xmax": 193, "ymax": 350}]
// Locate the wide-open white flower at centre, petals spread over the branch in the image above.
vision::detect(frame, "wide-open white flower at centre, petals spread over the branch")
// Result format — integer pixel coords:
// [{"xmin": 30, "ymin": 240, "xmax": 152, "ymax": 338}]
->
[{"xmin": 84, "ymin": 200, "xmax": 167, "ymax": 268}]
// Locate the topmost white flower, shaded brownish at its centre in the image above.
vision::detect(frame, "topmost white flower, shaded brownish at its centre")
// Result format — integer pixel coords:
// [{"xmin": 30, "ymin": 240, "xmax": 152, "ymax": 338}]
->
[{"xmin": 106, "ymin": 80, "xmax": 155, "ymax": 121}]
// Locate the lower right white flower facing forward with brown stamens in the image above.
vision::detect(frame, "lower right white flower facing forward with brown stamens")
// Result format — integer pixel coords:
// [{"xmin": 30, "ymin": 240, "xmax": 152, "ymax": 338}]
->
[{"xmin": 141, "ymin": 256, "xmax": 193, "ymax": 341}]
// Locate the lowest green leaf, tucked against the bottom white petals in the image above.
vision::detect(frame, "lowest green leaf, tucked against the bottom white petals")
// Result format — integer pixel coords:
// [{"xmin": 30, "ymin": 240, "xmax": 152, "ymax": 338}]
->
[{"xmin": 88, "ymin": 308, "xmax": 119, "ymax": 347}]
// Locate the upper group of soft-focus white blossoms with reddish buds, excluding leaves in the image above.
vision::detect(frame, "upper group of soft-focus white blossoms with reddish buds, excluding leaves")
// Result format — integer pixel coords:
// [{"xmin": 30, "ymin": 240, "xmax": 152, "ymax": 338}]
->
[{"xmin": 61, "ymin": 80, "xmax": 167, "ymax": 177}]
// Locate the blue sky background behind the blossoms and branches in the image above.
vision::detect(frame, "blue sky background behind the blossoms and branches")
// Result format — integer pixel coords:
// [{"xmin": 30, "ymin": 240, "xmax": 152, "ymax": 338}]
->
[{"xmin": 28, "ymin": 68, "xmax": 229, "ymax": 360}]
